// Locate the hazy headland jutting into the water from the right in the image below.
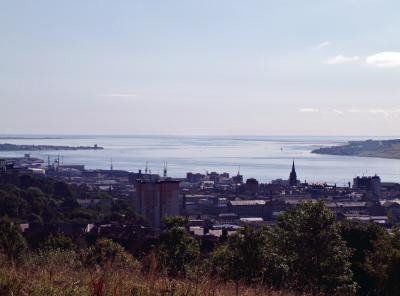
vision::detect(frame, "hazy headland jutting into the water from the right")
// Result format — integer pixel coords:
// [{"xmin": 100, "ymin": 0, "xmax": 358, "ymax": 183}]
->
[{"xmin": 312, "ymin": 139, "xmax": 400, "ymax": 159}]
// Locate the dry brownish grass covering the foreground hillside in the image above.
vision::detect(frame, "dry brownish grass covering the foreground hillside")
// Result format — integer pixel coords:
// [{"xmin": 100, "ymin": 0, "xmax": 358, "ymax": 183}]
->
[{"xmin": 0, "ymin": 251, "xmax": 295, "ymax": 296}]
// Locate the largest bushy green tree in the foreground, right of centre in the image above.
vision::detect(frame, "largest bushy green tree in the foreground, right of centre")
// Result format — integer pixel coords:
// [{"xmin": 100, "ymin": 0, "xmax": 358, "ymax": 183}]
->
[{"xmin": 276, "ymin": 202, "xmax": 354, "ymax": 294}]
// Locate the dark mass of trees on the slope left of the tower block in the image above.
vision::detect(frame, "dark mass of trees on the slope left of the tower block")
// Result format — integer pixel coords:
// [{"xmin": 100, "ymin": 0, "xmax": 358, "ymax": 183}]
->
[{"xmin": 0, "ymin": 174, "xmax": 140, "ymax": 225}]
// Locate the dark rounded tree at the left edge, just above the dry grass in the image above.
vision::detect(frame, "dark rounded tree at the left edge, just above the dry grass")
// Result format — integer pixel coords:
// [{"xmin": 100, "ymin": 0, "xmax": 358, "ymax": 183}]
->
[{"xmin": 0, "ymin": 218, "xmax": 26, "ymax": 261}]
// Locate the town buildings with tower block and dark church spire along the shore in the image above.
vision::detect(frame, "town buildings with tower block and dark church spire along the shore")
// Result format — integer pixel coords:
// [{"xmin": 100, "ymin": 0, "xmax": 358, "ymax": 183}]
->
[{"xmin": 0, "ymin": 157, "xmax": 400, "ymax": 239}]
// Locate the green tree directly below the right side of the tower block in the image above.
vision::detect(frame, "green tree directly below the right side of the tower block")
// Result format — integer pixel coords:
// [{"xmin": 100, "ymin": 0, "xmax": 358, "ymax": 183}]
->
[{"xmin": 156, "ymin": 217, "xmax": 199, "ymax": 277}]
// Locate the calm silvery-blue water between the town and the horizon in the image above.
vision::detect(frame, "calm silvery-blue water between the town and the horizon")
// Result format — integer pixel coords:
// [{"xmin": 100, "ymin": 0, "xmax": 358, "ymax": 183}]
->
[{"xmin": 0, "ymin": 136, "xmax": 400, "ymax": 185}]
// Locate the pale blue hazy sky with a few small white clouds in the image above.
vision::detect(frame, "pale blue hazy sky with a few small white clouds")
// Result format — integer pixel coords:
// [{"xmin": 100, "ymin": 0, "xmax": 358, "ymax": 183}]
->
[{"xmin": 0, "ymin": 0, "xmax": 400, "ymax": 136}]
